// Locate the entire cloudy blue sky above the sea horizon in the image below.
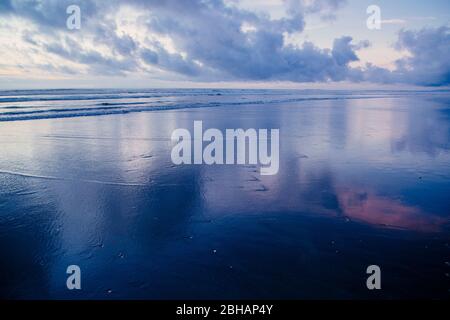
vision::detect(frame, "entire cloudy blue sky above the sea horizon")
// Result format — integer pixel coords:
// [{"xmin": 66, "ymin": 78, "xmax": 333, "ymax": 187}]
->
[{"xmin": 0, "ymin": 0, "xmax": 450, "ymax": 89}]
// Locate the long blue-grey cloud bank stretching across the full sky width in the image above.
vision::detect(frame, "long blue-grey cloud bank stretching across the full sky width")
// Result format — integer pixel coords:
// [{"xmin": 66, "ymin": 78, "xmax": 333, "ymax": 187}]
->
[{"xmin": 0, "ymin": 0, "xmax": 450, "ymax": 86}]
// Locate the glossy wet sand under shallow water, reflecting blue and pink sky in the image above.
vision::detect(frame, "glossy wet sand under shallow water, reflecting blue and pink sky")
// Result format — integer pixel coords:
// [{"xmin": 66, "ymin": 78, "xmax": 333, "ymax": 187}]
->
[{"xmin": 0, "ymin": 91, "xmax": 450, "ymax": 299}]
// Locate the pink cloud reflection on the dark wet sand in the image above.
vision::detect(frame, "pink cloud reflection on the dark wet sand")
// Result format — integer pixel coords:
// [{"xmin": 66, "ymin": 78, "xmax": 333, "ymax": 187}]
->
[{"xmin": 338, "ymin": 190, "xmax": 448, "ymax": 232}]
